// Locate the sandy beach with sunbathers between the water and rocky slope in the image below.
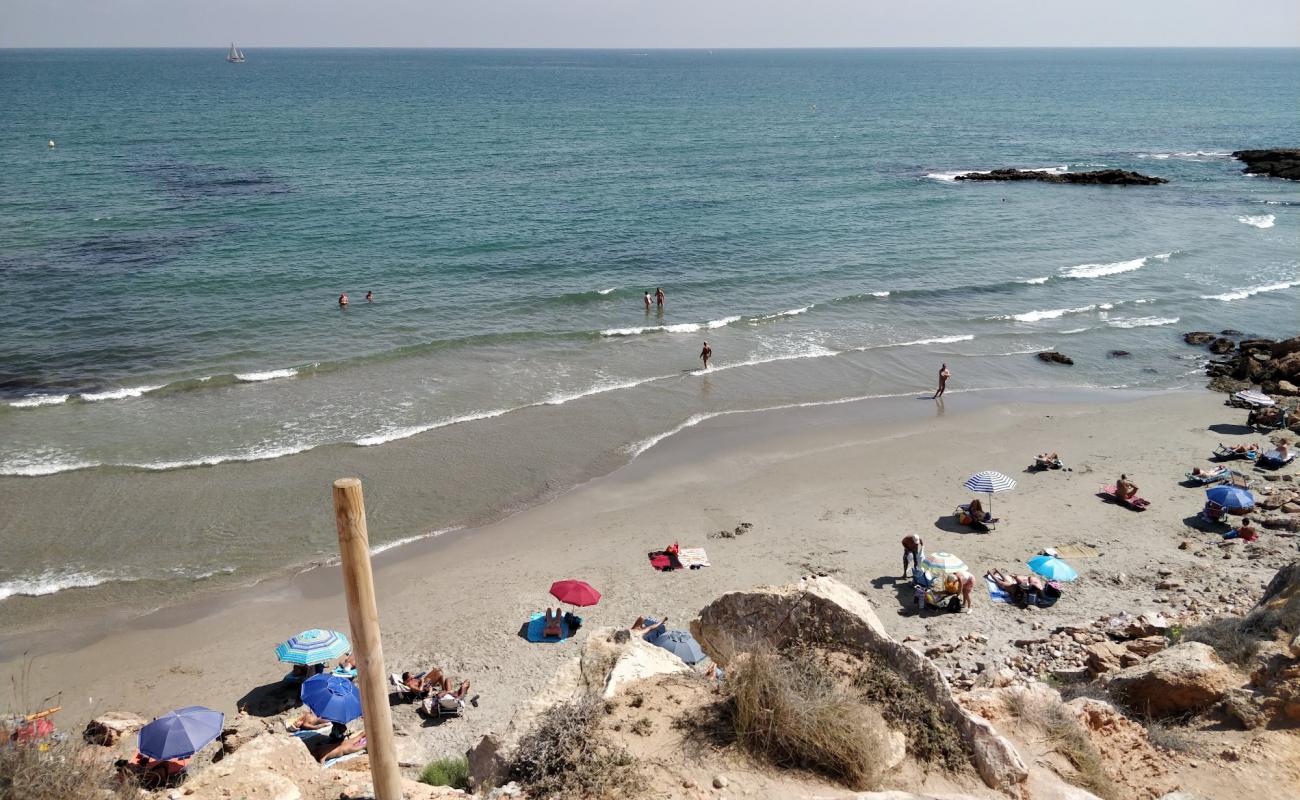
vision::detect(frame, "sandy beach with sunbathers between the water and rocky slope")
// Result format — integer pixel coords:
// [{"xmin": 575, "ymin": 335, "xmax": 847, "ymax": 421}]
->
[{"xmin": 0, "ymin": 392, "xmax": 1294, "ymax": 765}]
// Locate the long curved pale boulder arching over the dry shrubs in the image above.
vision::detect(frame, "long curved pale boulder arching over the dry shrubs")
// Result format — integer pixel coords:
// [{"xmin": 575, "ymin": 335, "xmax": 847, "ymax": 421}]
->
[{"xmin": 690, "ymin": 578, "xmax": 1028, "ymax": 788}]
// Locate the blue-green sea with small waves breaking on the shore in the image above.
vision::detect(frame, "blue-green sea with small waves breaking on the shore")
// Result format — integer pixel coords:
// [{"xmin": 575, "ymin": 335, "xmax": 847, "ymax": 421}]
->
[{"xmin": 0, "ymin": 42, "xmax": 1300, "ymax": 624}]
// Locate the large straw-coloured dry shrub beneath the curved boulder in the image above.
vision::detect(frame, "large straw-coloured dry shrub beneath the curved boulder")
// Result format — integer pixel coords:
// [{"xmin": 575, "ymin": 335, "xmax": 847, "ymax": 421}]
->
[{"xmin": 725, "ymin": 650, "xmax": 887, "ymax": 790}]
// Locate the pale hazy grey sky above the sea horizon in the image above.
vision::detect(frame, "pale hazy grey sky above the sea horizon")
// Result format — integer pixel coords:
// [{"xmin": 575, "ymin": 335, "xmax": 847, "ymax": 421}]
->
[{"xmin": 0, "ymin": 0, "xmax": 1300, "ymax": 48}]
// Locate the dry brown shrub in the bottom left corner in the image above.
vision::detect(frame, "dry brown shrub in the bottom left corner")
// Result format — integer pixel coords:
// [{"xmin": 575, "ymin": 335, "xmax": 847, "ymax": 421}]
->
[{"xmin": 0, "ymin": 740, "xmax": 137, "ymax": 800}]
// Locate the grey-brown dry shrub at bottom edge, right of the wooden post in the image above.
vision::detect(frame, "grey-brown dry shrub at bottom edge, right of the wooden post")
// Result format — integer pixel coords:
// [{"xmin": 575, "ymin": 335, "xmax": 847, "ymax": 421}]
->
[{"xmin": 510, "ymin": 699, "xmax": 645, "ymax": 800}]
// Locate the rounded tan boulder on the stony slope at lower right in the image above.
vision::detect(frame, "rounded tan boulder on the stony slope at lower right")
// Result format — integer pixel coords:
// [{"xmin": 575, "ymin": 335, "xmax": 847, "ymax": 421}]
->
[{"xmin": 1108, "ymin": 641, "xmax": 1242, "ymax": 717}]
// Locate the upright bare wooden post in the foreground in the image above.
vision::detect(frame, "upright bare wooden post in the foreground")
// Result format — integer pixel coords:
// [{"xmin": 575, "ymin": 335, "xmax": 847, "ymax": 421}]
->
[{"xmin": 334, "ymin": 477, "xmax": 402, "ymax": 800}]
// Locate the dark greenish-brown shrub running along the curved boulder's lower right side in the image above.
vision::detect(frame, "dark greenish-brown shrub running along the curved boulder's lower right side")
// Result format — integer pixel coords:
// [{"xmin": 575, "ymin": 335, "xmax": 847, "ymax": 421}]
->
[{"xmin": 853, "ymin": 657, "xmax": 970, "ymax": 771}]
